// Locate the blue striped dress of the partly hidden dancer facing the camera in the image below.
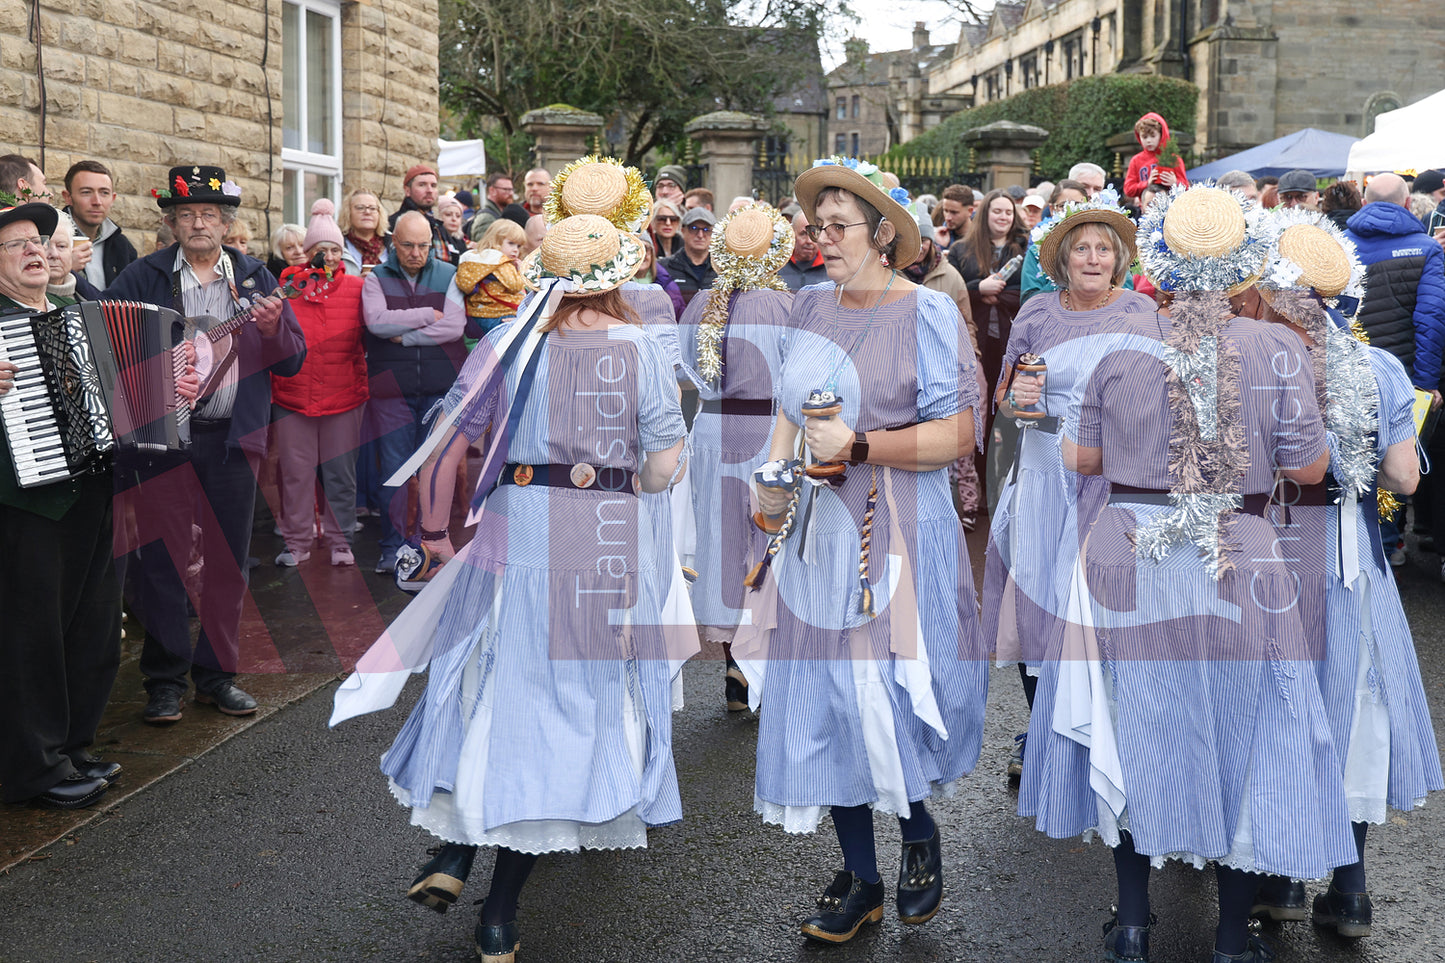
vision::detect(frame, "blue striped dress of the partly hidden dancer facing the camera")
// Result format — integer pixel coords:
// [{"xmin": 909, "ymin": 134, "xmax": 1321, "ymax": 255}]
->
[{"xmin": 983, "ymin": 291, "xmax": 1159, "ymax": 667}]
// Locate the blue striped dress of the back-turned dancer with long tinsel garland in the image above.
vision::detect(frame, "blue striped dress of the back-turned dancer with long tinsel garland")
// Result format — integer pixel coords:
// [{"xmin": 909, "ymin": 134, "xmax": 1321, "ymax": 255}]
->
[{"xmin": 1019, "ymin": 318, "xmax": 1355, "ymax": 878}]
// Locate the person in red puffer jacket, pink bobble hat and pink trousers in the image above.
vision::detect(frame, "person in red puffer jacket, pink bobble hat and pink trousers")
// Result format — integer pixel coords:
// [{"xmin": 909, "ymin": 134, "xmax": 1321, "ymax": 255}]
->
[{"xmin": 272, "ymin": 198, "xmax": 367, "ymax": 567}]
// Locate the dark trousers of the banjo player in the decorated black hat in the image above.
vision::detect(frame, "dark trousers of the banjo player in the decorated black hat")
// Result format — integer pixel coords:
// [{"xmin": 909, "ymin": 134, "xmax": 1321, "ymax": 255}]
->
[{"xmin": 118, "ymin": 425, "xmax": 259, "ymax": 693}]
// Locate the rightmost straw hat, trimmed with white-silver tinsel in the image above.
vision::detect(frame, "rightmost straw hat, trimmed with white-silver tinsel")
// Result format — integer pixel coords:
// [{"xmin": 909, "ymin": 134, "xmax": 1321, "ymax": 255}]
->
[{"xmin": 1257, "ymin": 207, "xmax": 1364, "ymax": 309}]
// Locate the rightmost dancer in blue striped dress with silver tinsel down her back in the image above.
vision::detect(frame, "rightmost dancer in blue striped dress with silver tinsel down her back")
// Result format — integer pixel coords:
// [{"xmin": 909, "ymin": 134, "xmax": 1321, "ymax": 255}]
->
[{"xmin": 1256, "ymin": 208, "xmax": 1442, "ymax": 937}]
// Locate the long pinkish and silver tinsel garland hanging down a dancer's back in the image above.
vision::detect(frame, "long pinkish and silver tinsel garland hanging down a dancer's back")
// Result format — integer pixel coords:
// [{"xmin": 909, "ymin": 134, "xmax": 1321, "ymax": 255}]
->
[{"xmin": 1131, "ymin": 291, "xmax": 1248, "ymax": 581}]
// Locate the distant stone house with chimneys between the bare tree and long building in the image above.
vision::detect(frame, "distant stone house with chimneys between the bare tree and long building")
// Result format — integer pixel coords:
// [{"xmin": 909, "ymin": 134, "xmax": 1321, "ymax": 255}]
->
[{"xmin": 828, "ymin": 23, "xmax": 968, "ymax": 156}]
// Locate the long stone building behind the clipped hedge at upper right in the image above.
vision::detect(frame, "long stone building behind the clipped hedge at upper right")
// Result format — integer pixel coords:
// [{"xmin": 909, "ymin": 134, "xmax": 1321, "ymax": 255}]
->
[{"xmin": 928, "ymin": 0, "xmax": 1445, "ymax": 158}]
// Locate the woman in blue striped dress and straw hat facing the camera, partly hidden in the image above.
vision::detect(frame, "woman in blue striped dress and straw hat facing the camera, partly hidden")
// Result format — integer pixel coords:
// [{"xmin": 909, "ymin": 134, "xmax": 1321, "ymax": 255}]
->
[{"xmin": 983, "ymin": 194, "xmax": 1155, "ymax": 775}]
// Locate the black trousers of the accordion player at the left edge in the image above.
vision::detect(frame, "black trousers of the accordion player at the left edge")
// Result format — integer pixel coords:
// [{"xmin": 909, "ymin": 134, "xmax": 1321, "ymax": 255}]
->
[{"xmin": 0, "ymin": 474, "xmax": 120, "ymax": 803}]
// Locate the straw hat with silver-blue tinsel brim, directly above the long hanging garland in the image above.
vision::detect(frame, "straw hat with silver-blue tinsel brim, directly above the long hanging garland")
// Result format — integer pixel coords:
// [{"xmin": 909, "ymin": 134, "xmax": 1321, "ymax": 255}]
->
[{"xmin": 1136, "ymin": 184, "xmax": 1269, "ymax": 295}]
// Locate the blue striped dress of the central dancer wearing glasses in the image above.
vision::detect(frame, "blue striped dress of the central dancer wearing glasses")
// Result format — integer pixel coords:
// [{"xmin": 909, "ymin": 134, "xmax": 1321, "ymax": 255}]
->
[{"xmin": 733, "ymin": 283, "xmax": 988, "ymax": 831}]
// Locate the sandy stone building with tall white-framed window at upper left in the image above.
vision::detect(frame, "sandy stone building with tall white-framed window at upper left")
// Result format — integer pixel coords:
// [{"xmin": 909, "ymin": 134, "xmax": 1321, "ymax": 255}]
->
[{"xmin": 0, "ymin": 0, "xmax": 438, "ymax": 247}]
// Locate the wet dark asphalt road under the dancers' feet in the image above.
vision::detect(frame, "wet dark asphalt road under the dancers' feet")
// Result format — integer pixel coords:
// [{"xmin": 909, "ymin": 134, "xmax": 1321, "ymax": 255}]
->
[{"xmin": 0, "ymin": 549, "xmax": 1445, "ymax": 963}]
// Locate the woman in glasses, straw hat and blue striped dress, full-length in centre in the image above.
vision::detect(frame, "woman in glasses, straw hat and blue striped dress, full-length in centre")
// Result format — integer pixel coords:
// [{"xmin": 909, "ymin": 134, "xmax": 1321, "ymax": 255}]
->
[{"xmin": 734, "ymin": 159, "xmax": 988, "ymax": 943}]
